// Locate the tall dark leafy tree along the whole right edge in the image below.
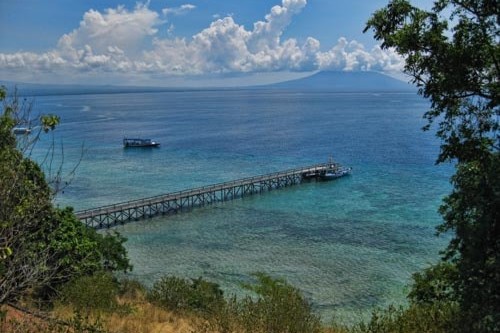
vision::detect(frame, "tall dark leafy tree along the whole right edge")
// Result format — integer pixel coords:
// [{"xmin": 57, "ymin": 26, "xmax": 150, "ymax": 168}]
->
[{"xmin": 365, "ymin": 0, "xmax": 500, "ymax": 332}]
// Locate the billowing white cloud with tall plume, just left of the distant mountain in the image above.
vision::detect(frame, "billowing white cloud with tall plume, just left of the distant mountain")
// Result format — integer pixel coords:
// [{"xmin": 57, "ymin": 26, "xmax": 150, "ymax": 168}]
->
[{"xmin": 147, "ymin": 0, "xmax": 326, "ymax": 74}]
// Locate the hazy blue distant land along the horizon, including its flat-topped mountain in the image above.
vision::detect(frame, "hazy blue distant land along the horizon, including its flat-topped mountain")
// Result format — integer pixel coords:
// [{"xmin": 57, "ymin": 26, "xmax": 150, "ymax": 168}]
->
[{"xmin": 0, "ymin": 71, "xmax": 415, "ymax": 96}]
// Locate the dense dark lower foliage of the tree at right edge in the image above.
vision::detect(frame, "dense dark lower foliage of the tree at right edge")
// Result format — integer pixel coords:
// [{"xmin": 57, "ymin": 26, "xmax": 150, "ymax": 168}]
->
[{"xmin": 441, "ymin": 153, "xmax": 500, "ymax": 332}]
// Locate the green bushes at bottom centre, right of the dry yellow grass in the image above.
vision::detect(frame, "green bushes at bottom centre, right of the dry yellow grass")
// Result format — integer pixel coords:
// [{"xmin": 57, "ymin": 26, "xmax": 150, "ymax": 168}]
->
[{"xmin": 148, "ymin": 273, "xmax": 321, "ymax": 333}]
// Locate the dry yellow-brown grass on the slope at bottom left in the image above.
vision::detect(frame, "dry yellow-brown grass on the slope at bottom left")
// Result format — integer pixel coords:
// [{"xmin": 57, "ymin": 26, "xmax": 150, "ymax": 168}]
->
[{"xmin": 0, "ymin": 278, "xmax": 348, "ymax": 333}]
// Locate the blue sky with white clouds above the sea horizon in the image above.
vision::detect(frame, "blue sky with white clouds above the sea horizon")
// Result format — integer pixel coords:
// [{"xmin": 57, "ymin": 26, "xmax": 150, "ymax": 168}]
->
[{"xmin": 0, "ymin": 0, "xmax": 432, "ymax": 86}]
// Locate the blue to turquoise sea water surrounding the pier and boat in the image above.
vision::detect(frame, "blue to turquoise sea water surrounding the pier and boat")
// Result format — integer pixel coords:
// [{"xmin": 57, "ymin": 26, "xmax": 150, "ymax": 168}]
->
[{"xmin": 31, "ymin": 90, "xmax": 451, "ymax": 322}]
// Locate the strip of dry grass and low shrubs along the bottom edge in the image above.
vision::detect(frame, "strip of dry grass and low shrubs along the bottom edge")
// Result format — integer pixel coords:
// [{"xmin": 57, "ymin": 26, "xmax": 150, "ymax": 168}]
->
[{"xmin": 0, "ymin": 274, "xmax": 457, "ymax": 333}]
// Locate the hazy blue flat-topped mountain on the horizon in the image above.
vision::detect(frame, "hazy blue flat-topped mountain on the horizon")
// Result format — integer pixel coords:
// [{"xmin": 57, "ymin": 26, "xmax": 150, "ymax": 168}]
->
[{"xmin": 262, "ymin": 72, "xmax": 416, "ymax": 92}]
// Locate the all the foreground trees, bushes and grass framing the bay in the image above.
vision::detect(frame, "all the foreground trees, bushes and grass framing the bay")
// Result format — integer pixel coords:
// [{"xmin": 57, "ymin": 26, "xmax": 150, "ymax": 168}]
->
[{"xmin": 0, "ymin": 0, "xmax": 500, "ymax": 333}]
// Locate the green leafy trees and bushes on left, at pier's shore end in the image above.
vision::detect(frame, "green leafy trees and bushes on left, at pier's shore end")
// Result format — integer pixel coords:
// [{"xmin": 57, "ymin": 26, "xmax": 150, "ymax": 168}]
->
[{"xmin": 0, "ymin": 88, "xmax": 131, "ymax": 305}]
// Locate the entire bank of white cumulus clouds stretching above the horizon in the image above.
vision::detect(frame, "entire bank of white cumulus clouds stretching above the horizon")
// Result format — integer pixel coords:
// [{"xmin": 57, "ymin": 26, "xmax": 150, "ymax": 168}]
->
[{"xmin": 0, "ymin": 0, "xmax": 403, "ymax": 84}]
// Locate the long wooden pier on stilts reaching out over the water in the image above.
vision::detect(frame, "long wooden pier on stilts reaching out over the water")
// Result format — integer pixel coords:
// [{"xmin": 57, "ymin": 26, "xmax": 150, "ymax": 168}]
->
[{"xmin": 76, "ymin": 163, "xmax": 331, "ymax": 229}]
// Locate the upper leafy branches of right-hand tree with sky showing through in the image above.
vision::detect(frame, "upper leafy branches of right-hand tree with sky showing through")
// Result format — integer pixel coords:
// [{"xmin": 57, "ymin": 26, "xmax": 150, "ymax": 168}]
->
[{"xmin": 365, "ymin": 0, "xmax": 500, "ymax": 163}]
